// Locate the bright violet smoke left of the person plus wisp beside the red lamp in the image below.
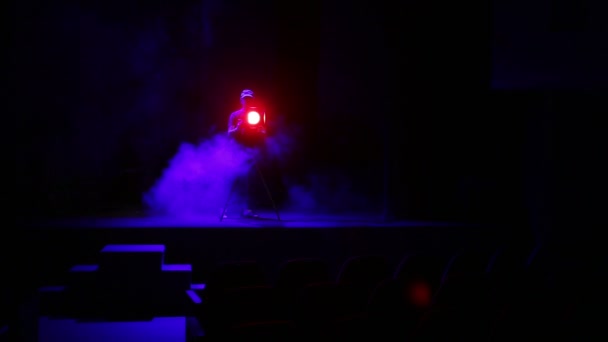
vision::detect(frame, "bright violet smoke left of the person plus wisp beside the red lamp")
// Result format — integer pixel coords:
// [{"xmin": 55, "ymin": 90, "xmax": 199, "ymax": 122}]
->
[{"xmin": 144, "ymin": 113, "xmax": 298, "ymax": 218}]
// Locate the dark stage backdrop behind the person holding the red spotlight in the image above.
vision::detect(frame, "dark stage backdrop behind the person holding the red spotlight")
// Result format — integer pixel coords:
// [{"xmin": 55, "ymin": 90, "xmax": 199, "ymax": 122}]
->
[{"xmin": 8, "ymin": 0, "xmax": 608, "ymax": 244}]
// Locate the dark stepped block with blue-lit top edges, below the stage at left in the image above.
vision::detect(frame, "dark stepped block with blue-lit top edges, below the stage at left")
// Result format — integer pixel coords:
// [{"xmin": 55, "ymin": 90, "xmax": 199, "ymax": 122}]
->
[{"xmin": 57, "ymin": 244, "xmax": 192, "ymax": 320}]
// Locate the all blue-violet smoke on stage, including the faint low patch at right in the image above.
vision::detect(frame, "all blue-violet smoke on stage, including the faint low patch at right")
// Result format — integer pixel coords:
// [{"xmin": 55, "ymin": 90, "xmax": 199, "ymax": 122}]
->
[{"xmin": 144, "ymin": 116, "xmax": 378, "ymax": 218}]
